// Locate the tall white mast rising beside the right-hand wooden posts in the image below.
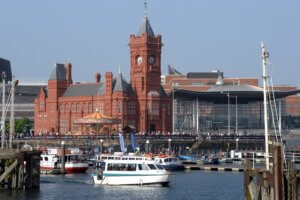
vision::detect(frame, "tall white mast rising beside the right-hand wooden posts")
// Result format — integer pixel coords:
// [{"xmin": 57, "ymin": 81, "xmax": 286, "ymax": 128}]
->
[{"xmin": 261, "ymin": 43, "xmax": 270, "ymax": 170}]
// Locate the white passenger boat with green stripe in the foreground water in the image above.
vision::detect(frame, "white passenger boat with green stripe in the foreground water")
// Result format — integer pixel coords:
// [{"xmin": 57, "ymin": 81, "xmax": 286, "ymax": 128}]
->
[{"xmin": 92, "ymin": 160, "xmax": 169, "ymax": 186}]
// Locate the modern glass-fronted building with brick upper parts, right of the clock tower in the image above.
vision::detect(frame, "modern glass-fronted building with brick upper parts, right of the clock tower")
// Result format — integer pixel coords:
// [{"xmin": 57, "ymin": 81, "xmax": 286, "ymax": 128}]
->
[{"xmin": 162, "ymin": 66, "xmax": 300, "ymax": 134}]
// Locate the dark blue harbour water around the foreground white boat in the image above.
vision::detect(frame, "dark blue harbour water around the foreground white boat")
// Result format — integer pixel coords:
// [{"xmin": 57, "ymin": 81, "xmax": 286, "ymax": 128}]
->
[{"xmin": 0, "ymin": 171, "xmax": 244, "ymax": 200}]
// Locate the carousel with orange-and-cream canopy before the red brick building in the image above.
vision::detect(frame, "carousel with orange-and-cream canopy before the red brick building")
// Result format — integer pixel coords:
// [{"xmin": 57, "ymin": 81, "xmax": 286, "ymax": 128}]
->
[{"xmin": 74, "ymin": 112, "xmax": 121, "ymax": 135}]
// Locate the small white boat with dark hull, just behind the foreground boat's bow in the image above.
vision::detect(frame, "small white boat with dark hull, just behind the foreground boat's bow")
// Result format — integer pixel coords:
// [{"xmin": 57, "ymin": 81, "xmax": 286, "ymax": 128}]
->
[{"xmin": 154, "ymin": 156, "xmax": 184, "ymax": 171}]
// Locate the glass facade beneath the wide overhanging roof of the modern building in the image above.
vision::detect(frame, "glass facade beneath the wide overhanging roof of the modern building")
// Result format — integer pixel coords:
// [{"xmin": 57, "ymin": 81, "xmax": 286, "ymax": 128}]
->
[{"xmin": 173, "ymin": 96, "xmax": 300, "ymax": 133}]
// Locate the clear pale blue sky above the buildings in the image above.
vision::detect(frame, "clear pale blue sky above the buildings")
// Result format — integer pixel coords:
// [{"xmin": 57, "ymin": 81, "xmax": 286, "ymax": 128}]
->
[{"xmin": 0, "ymin": 0, "xmax": 300, "ymax": 87}]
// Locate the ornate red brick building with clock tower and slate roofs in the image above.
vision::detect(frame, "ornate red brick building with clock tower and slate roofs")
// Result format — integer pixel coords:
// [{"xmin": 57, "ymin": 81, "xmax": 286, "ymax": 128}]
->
[{"xmin": 34, "ymin": 16, "xmax": 172, "ymax": 134}]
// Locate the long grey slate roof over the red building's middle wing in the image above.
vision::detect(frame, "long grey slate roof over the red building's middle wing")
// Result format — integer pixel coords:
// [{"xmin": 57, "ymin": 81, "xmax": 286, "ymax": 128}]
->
[{"xmin": 63, "ymin": 83, "xmax": 105, "ymax": 97}]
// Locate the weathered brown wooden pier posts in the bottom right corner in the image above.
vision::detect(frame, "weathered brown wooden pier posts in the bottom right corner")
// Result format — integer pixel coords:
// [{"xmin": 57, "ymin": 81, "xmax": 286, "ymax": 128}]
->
[{"xmin": 244, "ymin": 143, "xmax": 300, "ymax": 200}]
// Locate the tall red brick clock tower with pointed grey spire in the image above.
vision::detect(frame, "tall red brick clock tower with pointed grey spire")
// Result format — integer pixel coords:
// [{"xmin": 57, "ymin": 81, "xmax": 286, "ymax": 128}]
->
[{"xmin": 130, "ymin": 14, "xmax": 162, "ymax": 132}]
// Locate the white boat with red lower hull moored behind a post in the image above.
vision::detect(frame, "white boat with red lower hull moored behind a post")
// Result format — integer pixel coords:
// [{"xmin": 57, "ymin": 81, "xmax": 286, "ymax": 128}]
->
[{"xmin": 40, "ymin": 148, "xmax": 88, "ymax": 174}]
